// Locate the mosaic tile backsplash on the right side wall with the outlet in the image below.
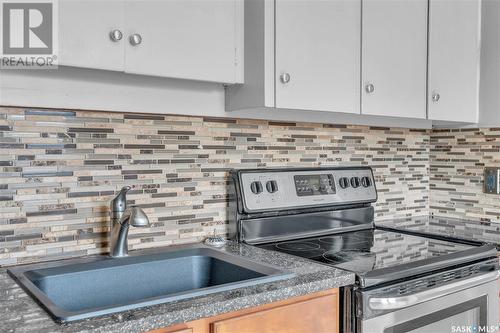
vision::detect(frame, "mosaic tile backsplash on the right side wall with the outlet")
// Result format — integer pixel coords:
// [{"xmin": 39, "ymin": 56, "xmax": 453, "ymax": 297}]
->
[{"xmin": 429, "ymin": 128, "xmax": 500, "ymax": 222}]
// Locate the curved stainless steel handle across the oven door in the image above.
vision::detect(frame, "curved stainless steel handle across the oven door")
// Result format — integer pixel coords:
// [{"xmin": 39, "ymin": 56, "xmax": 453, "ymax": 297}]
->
[{"xmin": 368, "ymin": 271, "xmax": 500, "ymax": 310}]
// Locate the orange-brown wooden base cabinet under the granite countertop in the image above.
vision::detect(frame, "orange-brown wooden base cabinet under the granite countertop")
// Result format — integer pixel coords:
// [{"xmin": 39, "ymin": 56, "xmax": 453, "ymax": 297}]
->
[{"xmin": 149, "ymin": 289, "xmax": 339, "ymax": 333}]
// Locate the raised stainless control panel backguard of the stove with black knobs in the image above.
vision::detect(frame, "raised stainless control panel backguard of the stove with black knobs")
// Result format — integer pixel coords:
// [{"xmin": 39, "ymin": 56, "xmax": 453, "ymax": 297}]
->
[{"xmin": 229, "ymin": 166, "xmax": 377, "ymax": 244}]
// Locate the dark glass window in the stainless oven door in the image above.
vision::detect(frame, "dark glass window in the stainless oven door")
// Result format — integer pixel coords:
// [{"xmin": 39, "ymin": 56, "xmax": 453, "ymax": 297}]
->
[{"xmin": 384, "ymin": 295, "xmax": 488, "ymax": 333}]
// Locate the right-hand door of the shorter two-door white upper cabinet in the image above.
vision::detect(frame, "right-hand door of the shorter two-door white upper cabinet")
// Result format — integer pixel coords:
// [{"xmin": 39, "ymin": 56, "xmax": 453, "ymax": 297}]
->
[{"xmin": 125, "ymin": 0, "xmax": 242, "ymax": 83}]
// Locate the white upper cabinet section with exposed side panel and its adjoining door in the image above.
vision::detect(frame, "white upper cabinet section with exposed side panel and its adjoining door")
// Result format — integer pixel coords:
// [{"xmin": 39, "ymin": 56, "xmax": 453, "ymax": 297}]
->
[{"xmin": 226, "ymin": 0, "xmax": 361, "ymax": 114}]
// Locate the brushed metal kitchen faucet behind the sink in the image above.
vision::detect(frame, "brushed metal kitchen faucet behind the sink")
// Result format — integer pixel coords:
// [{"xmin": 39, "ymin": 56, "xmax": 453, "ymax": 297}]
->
[{"xmin": 109, "ymin": 186, "xmax": 149, "ymax": 258}]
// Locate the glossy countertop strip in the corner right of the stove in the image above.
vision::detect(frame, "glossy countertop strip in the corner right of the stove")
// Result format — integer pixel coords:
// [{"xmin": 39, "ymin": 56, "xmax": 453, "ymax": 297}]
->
[{"xmin": 375, "ymin": 216, "xmax": 500, "ymax": 250}]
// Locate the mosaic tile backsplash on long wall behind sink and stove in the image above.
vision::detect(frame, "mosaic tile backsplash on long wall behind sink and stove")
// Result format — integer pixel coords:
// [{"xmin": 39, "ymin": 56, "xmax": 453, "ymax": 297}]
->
[{"xmin": 0, "ymin": 108, "xmax": 430, "ymax": 265}]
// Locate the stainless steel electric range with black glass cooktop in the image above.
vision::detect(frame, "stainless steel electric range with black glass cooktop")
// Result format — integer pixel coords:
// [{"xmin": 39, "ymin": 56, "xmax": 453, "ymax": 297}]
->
[{"xmin": 230, "ymin": 167, "xmax": 498, "ymax": 333}]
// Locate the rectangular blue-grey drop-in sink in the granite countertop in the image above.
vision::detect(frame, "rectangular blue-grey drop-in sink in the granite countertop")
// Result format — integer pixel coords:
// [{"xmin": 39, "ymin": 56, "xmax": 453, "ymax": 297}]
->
[{"xmin": 9, "ymin": 246, "xmax": 292, "ymax": 322}]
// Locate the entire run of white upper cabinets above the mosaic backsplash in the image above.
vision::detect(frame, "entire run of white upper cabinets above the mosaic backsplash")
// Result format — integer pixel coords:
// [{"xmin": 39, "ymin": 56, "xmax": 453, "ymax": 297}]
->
[{"xmin": 55, "ymin": 0, "xmax": 484, "ymax": 124}]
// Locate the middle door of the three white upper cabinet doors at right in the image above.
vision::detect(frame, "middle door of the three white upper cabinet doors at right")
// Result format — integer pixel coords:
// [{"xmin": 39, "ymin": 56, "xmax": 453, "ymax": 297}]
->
[{"xmin": 361, "ymin": 0, "xmax": 428, "ymax": 118}]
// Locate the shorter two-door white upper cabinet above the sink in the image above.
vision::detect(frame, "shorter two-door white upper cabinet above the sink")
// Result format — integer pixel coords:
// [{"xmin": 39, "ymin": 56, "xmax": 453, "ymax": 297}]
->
[{"xmin": 59, "ymin": 0, "xmax": 243, "ymax": 83}]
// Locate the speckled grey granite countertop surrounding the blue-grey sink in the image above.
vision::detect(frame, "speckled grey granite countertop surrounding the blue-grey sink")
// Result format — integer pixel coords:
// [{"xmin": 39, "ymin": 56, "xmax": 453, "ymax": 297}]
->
[{"xmin": 0, "ymin": 242, "xmax": 354, "ymax": 333}]
